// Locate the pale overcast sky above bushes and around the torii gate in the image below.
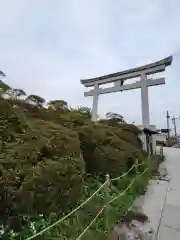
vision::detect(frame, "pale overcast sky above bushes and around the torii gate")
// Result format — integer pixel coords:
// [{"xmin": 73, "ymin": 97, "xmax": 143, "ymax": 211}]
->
[{"xmin": 0, "ymin": 0, "xmax": 180, "ymax": 131}]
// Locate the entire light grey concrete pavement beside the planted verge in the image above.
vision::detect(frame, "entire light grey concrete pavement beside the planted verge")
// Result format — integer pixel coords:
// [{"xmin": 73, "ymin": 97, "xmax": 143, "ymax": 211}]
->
[{"xmin": 110, "ymin": 148, "xmax": 180, "ymax": 240}]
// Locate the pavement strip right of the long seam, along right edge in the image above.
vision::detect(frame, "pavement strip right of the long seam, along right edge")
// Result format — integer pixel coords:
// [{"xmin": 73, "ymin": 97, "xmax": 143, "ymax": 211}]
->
[{"xmin": 157, "ymin": 148, "xmax": 180, "ymax": 240}]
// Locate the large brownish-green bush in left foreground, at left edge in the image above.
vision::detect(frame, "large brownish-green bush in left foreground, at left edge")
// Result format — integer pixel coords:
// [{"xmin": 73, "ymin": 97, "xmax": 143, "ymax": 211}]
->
[{"xmin": 0, "ymin": 103, "xmax": 84, "ymax": 238}]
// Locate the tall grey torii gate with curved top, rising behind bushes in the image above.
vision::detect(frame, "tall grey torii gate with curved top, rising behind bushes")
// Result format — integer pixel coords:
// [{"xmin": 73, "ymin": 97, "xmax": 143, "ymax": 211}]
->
[{"xmin": 81, "ymin": 56, "xmax": 173, "ymax": 126}]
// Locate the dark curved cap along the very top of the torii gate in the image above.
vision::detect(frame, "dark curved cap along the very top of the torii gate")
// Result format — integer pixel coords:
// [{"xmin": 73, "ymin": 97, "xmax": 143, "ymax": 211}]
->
[{"xmin": 81, "ymin": 56, "xmax": 173, "ymax": 84}]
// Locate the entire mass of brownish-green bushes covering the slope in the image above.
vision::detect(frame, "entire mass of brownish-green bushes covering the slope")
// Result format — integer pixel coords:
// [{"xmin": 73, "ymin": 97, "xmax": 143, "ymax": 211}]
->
[{"xmin": 0, "ymin": 82, "xmax": 148, "ymax": 239}]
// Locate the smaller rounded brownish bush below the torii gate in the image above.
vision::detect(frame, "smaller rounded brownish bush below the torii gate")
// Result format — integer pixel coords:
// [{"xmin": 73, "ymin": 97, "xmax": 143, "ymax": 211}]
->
[{"xmin": 79, "ymin": 124, "xmax": 143, "ymax": 176}]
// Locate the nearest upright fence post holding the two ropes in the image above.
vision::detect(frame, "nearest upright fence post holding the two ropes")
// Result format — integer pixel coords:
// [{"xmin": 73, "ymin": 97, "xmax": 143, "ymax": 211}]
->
[{"xmin": 104, "ymin": 174, "xmax": 110, "ymax": 232}]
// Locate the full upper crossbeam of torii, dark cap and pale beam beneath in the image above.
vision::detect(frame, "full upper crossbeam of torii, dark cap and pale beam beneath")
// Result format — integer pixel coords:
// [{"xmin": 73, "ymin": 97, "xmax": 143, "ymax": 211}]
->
[{"xmin": 81, "ymin": 56, "xmax": 172, "ymax": 87}]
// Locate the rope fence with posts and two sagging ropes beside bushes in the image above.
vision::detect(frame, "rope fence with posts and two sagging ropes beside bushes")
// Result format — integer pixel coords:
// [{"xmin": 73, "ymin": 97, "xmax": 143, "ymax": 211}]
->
[{"xmin": 26, "ymin": 160, "xmax": 149, "ymax": 240}]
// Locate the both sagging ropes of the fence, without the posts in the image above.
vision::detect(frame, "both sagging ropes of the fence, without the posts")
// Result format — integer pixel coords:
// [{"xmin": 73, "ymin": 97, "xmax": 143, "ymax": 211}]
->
[{"xmin": 26, "ymin": 159, "xmax": 148, "ymax": 240}]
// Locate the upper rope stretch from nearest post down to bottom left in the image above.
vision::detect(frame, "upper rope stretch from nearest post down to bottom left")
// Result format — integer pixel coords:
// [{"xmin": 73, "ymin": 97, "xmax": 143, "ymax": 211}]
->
[{"xmin": 26, "ymin": 181, "xmax": 107, "ymax": 240}]
